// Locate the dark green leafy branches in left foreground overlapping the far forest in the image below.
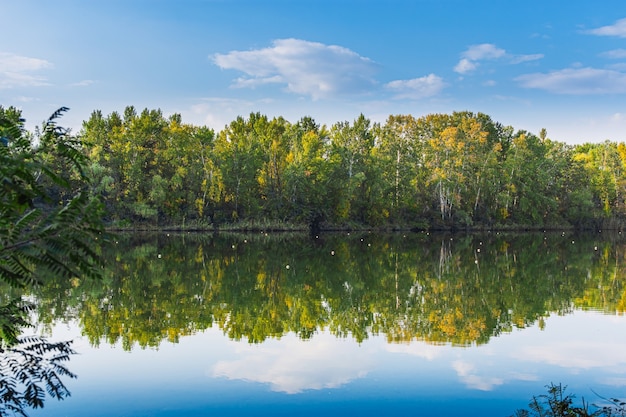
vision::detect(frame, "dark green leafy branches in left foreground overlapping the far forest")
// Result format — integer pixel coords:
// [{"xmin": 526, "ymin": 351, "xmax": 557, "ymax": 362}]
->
[{"xmin": 0, "ymin": 107, "xmax": 103, "ymax": 287}]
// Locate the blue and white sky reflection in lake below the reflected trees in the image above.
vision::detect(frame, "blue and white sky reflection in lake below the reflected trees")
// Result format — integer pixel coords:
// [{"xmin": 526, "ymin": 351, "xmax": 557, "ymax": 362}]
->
[{"xmin": 31, "ymin": 311, "xmax": 626, "ymax": 416}]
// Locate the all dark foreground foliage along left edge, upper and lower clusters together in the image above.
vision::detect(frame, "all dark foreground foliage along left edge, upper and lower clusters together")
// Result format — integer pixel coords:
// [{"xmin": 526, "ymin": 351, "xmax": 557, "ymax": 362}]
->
[{"xmin": 0, "ymin": 106, "xmax": 104, "ymax": 416}]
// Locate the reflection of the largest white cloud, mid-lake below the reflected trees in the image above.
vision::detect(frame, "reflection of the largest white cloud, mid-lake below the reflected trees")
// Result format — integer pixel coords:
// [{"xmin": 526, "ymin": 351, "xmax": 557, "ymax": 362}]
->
[{"xmin": 212, "ymin": 334, "xmax": 374, "ymax": 394}]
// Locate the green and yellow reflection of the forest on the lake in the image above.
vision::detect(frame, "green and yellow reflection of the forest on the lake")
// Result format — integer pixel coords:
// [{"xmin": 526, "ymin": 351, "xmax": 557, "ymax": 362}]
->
[{"xmin": 31, "ymin": 234, "xmax": 626, "ymax": 349}]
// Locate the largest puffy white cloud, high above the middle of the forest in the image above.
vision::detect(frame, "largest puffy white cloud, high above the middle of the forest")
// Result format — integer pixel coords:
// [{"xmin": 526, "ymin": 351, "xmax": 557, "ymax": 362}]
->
[{"xmin": 212, "ymin": 39, "xmax": 376, "ymax": 99}]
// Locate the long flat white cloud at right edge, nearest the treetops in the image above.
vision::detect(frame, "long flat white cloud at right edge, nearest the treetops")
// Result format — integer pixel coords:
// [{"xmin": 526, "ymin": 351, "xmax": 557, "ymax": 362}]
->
[{"xmin": 516, "ymin": 67, "xmax": 626, "ymax": 95}]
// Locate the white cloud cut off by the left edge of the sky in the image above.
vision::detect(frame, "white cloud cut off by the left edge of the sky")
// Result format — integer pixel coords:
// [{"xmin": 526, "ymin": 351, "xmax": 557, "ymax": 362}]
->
[{"xmin": 0, "ymin": 52, "xmax": 52, "ymax": 89}]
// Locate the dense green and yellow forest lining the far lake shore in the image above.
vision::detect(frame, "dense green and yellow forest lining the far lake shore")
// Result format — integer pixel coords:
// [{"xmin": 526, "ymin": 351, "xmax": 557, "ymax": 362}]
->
[{"xmin": 0, "ymin": 106, "xmax": 626, "ymax": 229}]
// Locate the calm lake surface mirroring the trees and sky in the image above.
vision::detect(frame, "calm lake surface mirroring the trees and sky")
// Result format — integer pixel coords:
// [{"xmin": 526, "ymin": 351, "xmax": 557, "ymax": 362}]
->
[{"xmin": 13, "ymin": 232, "xmax": 626, "ymax": 417}]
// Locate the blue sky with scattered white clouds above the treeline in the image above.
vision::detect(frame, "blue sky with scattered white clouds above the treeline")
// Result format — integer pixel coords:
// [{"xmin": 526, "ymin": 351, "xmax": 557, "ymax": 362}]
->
[{"xmin": 0, "ymin": 0, "xmax": 626, "ymax": 143}]
